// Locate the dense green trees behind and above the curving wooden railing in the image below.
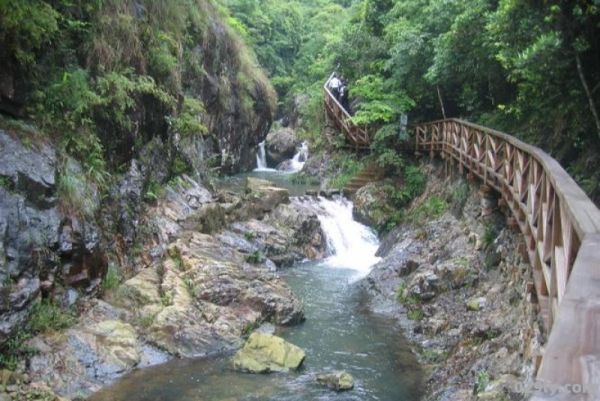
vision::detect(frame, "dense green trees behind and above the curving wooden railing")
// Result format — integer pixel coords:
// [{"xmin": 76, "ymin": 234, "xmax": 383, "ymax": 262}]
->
[{"xmin": 223, "ymin": 0, "xmax": 600, "ymax": 199}]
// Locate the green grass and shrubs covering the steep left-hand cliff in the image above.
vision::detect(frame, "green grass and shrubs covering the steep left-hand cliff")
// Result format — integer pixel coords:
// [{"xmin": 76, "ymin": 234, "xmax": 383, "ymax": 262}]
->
[{"xmin": 0, "ymin": 0, "xmax": 276, "ymax": 214}]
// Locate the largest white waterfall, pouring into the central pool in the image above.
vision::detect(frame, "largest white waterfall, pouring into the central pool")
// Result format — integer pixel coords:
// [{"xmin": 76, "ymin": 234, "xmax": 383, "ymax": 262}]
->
[{"xmin": 317, "ymin": 198, "xmax": 380, "ymax": 279}]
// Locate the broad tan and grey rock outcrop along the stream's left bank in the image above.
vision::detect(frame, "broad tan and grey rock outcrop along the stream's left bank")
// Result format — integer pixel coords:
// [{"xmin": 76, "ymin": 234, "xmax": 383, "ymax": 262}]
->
[{"xmin": 7, "ymin": 178, "xmax": 325, "ymax": 399}]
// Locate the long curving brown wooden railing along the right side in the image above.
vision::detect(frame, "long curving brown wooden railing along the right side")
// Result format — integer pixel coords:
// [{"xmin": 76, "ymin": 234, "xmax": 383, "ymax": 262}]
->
[{"xmin": 414, "ymin": 119, "xmax": 600, "ymax": 401}]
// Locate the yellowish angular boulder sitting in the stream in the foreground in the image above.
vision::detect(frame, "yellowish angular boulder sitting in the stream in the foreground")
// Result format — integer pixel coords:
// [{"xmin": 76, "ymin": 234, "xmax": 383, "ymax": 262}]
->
[{"xmin": 233, "ymin": 332, "xmax": 305, "ymax": 373}]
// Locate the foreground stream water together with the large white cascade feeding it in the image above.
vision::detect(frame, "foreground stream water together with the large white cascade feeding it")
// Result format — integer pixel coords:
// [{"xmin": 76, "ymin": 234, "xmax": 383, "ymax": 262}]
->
[{"xmin": 89, "ymin": 191, "xmax": 421, "ymax": 401}]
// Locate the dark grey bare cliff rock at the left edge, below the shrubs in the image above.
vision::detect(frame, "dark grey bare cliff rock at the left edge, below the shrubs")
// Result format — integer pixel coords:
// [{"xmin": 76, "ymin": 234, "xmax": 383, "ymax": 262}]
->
[{"xmin": 0, "ymin": 130, "xmax": 106, "ymax": 343}]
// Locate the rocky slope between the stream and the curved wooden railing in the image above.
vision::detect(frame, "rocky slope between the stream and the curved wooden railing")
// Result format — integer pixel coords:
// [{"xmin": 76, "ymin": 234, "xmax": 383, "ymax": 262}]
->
[{"xmin": 362, "ymin": 164, "xmax": 543, "ymax": 401}]
